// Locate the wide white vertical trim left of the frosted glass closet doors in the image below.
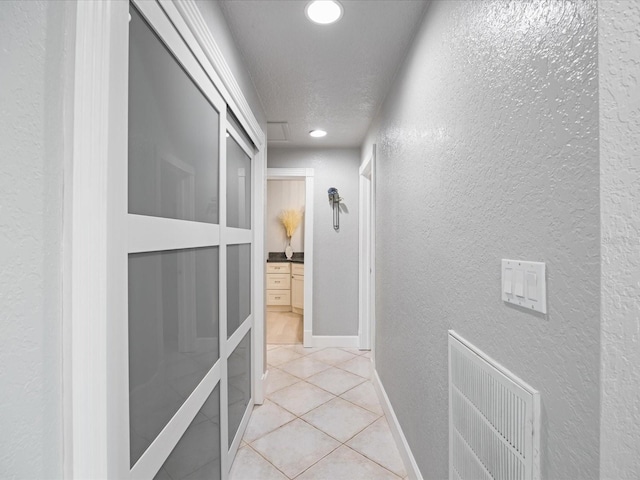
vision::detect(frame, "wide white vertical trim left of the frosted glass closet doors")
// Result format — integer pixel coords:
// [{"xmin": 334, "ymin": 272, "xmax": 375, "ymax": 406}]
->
[{"xmin": 69, "ymin": 2, "xmax": 129, "ymax": 478}]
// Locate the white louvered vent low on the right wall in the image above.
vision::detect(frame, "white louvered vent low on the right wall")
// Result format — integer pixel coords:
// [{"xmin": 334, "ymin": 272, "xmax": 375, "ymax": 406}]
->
[{"xmin": 449, "ymin": 330, "xmax": 540, "ymax": 480}]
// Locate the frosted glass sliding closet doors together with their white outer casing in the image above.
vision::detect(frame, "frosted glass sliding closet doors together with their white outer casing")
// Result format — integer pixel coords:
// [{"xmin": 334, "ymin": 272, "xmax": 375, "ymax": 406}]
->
[{"xmin": 64, "ymin": 0, "xmax": 264, "ymax": 479}]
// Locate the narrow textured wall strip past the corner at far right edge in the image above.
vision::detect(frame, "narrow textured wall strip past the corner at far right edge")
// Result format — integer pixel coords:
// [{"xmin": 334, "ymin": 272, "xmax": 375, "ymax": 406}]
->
[{"xmin": 598, "ymin": 0, "xmax": 640, "ymax": 479}]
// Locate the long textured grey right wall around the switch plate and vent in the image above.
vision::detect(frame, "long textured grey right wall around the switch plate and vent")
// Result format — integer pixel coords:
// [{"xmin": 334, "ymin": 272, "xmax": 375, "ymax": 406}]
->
[{"xmin": 363, "ymin": 0, "xmax": 600, "ymax": 480}]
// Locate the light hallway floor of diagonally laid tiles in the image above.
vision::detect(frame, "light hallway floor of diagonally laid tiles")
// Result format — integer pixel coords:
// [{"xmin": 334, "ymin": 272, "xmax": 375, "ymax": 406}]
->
[{"xmin": 230, "ymin": 345, "xmax": 406, "ymax": 480}]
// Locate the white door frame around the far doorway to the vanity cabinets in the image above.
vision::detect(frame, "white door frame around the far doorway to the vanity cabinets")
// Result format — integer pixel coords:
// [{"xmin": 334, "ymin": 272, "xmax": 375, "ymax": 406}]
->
[{"xmin": 262, "ymin": 168, "xmax": 314, "ymax": 347}]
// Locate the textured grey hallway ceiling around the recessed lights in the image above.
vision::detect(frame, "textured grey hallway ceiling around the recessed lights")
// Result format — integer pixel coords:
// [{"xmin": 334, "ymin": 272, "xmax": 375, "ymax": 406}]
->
[{"xmin": 220, "ymin": 0, "xmax": 426, "ymax": 147}]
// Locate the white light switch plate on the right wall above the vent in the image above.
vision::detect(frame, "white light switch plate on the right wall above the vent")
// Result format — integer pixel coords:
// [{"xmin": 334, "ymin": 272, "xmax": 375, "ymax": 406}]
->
[{"xmin": 501, "ymin": 259, "xmax": 547, "ymax": 313}]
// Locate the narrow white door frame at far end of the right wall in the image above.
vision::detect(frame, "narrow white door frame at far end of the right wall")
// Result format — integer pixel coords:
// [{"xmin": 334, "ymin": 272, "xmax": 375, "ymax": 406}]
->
[{"xmin": 358, "ymin": 144, "xmax": 376, "ymax": 357}]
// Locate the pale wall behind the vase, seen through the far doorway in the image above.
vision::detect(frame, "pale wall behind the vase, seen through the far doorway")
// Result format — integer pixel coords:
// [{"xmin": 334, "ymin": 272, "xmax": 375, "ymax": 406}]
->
[{"xmin": 264, "ymin": 180, "xmax": 305, "ymax": 253}]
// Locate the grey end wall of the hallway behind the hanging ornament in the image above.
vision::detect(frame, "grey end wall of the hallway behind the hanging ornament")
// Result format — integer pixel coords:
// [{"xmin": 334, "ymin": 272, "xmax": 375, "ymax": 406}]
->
[{"xmin": 268, "ymin": 148, "xmax": 360, "ymax": 336}]
